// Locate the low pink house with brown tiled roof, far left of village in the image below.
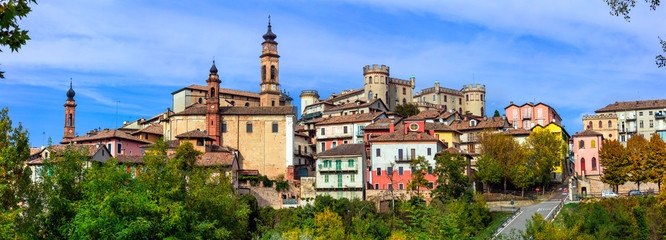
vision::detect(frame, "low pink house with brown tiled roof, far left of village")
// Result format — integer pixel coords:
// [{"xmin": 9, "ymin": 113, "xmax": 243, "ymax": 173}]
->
[{"xmin": 60, "ymin": 129, "xmax": 151, "ymax": 157}]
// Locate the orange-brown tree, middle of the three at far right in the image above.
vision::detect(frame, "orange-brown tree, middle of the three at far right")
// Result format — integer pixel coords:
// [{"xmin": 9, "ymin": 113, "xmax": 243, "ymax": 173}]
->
[{"xmin": 627, "ymin": 135, "xmax": 649, "ymax": 190}]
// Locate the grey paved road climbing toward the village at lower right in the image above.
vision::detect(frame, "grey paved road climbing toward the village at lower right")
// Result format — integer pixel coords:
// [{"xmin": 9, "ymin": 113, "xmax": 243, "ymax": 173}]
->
[{"xmin": 500, "ymin": 191, "xmax": 566, "ymax": 235}]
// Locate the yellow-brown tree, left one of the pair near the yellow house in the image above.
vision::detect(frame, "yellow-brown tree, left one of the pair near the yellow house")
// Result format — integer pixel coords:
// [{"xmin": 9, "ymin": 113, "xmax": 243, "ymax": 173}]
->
[{"xmin": 479, "ymin": 131, "xmax": 525, "ymax": 193}]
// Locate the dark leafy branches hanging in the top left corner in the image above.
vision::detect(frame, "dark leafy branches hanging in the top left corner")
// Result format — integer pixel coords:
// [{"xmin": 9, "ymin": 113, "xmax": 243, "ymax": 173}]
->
[{"xmin": 0, "ymin": 0, "xmax": 37, "ymax": 78}]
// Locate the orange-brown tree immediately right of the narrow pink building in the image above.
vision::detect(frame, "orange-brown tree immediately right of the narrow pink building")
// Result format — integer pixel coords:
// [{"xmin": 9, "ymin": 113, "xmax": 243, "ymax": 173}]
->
[{"xmin": 599, "ymin": 139, "xmax": 629, "ymax": 192}]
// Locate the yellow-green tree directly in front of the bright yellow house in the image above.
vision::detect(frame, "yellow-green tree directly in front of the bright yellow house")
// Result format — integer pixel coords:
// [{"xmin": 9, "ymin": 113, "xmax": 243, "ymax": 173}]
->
[{"xmin": 519, "ymin": 130, "xmax": 565, "ymax": 186}]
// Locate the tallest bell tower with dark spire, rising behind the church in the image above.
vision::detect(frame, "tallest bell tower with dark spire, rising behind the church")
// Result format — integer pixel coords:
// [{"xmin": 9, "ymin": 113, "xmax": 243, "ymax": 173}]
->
[{"xmin": 259, "ymin": 16, "xmax": 280, "ymax": 106}]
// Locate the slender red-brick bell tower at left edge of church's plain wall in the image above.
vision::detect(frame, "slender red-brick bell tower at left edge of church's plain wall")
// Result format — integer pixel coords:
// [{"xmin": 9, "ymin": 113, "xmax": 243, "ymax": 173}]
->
[{"xmin": 206, "ymin": 61, "xmax": 222, "ymax": 144}]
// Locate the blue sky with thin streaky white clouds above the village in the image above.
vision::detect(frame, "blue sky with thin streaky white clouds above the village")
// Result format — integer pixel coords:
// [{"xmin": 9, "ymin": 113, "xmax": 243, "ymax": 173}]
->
[{"xmin": 0, "ymin": 0, "xmax": 666, "ymax": 146}]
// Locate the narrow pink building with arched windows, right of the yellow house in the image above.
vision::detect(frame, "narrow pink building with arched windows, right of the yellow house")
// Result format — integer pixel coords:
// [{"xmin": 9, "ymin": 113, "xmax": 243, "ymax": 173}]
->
[{"xmin": 572, "ymin": 129, "xmax": 603, "ymax": 176}]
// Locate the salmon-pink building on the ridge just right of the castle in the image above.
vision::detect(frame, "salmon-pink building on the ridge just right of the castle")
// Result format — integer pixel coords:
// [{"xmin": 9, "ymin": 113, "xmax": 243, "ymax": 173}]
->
[{"xmin": 504, "ymin": 102, "xmax": 562, "ymax": 130}]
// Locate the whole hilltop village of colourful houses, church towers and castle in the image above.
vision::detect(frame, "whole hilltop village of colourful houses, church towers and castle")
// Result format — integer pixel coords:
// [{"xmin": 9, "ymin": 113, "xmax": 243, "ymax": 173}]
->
[{"xmin": 27, "ymin": 22, "xmax": 666, "ymax": 208}]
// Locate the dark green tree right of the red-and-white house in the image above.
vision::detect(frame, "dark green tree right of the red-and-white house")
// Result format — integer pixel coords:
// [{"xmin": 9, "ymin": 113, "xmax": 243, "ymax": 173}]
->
[{"xmin": 432, "ymin": 151, "xmax": 470, "ymax": 200}]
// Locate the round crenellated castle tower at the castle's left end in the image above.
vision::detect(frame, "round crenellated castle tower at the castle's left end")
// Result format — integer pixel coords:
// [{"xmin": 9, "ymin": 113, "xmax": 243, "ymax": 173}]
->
[{"xmin": 363, "ymin": 64, "xmax": 395, "ymax": 109}]
